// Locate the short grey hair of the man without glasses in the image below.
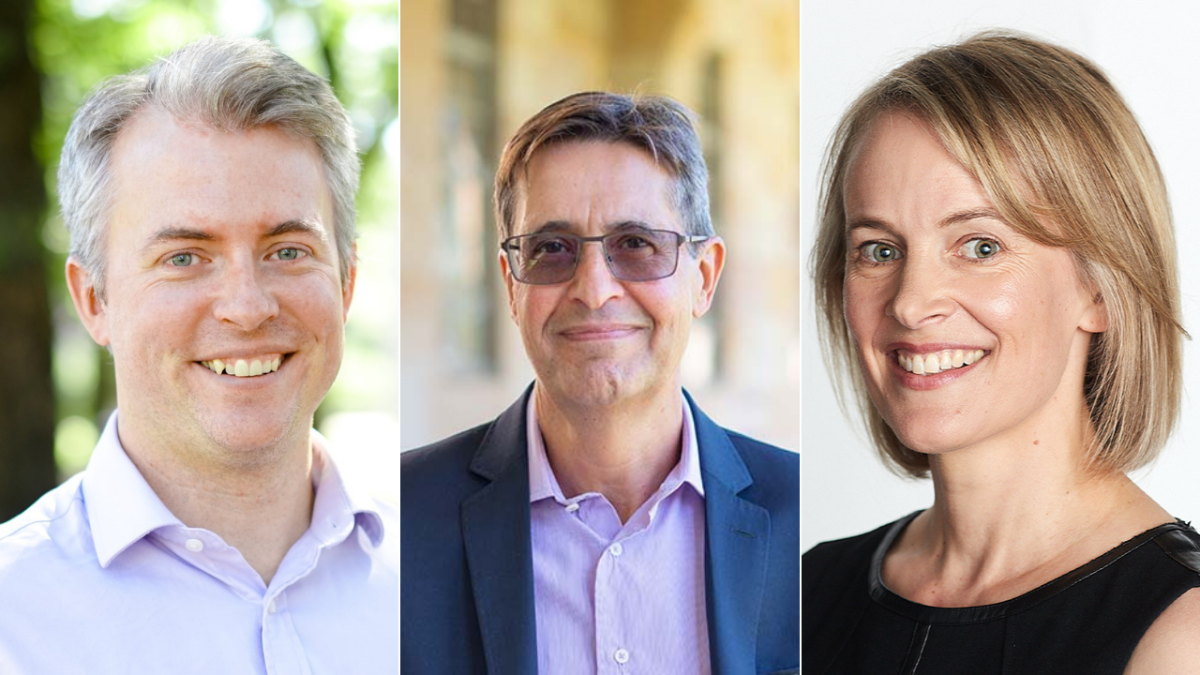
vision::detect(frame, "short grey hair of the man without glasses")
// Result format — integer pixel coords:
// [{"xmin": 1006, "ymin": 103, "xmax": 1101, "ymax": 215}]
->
[{"xmin": 59, "ymin": 37, "xmax": 360, "ymax": 294}]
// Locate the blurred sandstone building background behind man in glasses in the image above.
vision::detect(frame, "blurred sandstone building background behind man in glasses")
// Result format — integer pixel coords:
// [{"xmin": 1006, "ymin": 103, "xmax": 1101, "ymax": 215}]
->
[{"xmin": 401, "ymin": 0, "xmax": 800, "ymax": 449}]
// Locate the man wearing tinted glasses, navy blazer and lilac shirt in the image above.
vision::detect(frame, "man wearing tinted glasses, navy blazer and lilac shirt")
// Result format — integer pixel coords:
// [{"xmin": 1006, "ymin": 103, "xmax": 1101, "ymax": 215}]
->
[{"xmin": 401, "ymin": 92, "xmax": 799, "ymax": 674}]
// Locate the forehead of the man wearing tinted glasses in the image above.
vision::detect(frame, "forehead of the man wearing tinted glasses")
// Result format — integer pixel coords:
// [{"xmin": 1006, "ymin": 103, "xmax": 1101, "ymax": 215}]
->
[{"xmin": 516, "ymin": 141, "xmax": 679, "ymax": 233}]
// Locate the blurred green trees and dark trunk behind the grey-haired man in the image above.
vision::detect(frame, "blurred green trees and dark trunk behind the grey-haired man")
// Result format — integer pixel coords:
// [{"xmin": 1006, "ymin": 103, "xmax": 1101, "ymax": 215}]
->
[{"xmin": 0, "ymin": 0, "xmax": 400, "ymax": 521}]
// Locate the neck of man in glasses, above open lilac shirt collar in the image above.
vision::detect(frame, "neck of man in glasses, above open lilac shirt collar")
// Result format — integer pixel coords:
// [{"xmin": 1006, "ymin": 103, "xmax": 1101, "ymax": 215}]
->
[{"xmin": 533, "ymin": 386, "xmax": 684, "ymax": 522}]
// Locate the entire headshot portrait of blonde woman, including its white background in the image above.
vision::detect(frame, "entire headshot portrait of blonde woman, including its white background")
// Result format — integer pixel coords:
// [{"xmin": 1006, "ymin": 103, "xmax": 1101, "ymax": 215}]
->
[{"xmin": 802, "ymin": 2, "xmax": 1200, "ymax": 673}]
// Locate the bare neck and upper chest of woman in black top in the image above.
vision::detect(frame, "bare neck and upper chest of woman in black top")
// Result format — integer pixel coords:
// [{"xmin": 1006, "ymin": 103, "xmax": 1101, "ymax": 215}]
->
[{"xmin": 884, "ymin": 403, "xmax": 1170, "ymax": 607}]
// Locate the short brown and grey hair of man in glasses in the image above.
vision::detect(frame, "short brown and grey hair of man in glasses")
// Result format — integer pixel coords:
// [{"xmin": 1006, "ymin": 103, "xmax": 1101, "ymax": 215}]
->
[{"xmin": 494, "ymin": 91, "xmax": 713, "ymax": 243}]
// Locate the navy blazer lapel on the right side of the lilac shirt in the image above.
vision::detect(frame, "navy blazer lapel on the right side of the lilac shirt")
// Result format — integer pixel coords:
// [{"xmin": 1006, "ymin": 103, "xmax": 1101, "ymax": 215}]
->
[{"xmin": 685, "ymin": 393, "xmax": 770, "ymax": 675}]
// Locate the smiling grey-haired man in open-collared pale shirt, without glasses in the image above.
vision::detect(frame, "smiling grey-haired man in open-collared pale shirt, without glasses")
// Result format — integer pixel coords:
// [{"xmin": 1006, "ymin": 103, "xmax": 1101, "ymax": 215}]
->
[{"xmin": 0, "ymin": 38, "xmax": 398, "ymax": 674}]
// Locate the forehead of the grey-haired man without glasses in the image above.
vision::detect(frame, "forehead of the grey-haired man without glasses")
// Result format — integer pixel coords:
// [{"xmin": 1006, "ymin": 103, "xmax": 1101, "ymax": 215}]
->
[{"xmin": 109, "ymin": 107, "xmax": 332, "ymax": 239}]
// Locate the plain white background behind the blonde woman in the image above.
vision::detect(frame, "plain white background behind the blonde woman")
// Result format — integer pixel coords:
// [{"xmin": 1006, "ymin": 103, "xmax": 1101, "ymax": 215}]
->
[{"xmin": 800, "ymin": 0, "xmax": 1200, "ymax": 550}]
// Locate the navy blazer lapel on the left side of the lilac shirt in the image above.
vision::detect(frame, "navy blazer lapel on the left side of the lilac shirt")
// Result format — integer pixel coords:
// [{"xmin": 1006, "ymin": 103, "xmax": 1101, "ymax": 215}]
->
[{"xmin": 461, "ymin": 388, "xmax": 538, "ymax": 675}]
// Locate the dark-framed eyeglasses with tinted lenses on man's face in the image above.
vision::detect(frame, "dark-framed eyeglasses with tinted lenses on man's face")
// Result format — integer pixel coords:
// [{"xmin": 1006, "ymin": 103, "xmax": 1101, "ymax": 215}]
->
[{"xmin": 500, "ymin": 228, "xmax": 710, "ymax": 285}]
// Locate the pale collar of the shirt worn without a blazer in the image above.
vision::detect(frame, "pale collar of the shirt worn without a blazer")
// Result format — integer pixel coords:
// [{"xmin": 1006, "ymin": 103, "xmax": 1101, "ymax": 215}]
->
[{"xmin": 83, "ymin": 411, "xmax": 384, "ymax": 568}]
